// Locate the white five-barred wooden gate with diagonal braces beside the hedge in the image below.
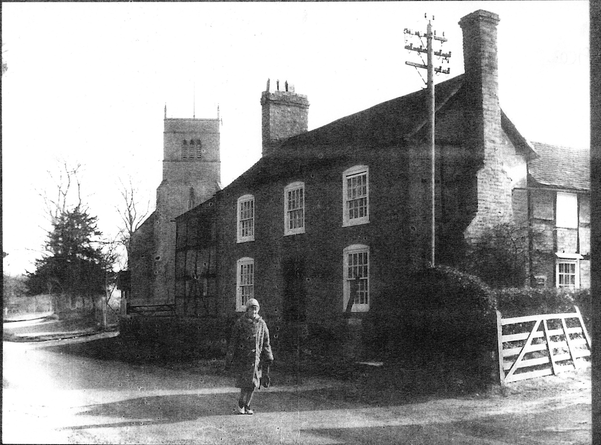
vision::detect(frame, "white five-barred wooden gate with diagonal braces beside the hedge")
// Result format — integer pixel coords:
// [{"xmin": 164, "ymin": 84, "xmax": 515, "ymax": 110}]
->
[{"xmin": 497, "ymin": 306, "xmax": 591, "ymax": 384}]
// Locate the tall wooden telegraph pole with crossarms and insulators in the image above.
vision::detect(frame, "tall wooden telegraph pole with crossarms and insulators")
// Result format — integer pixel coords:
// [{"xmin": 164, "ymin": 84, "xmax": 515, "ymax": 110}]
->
[{"xmin": 404, "ymin": 15, "xmax": 451, "ymax": 267}]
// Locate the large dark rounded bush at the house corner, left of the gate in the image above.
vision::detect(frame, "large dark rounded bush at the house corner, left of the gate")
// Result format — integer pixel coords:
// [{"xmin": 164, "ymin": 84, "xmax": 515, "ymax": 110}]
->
[{"xmin": 368, "ymin": 266, "xmax": 496, "ymax": 379}]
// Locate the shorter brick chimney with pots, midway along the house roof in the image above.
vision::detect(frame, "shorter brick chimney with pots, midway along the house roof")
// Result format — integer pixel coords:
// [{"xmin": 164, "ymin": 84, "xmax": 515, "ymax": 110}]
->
[{"xmin": 261, "ymin": 80, "xmax": 309, "ymax": 156}]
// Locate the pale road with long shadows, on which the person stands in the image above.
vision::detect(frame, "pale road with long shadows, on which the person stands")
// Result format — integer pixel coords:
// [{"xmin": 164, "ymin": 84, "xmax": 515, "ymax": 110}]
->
[{"xmin": 2, "ymin": 338, "xmax": 591, "ymax": 445}]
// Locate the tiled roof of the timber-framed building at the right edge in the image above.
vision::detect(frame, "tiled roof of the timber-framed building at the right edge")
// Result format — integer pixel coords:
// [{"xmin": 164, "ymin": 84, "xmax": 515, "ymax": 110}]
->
[{"xmin": 528, "ymin": 142, "xmax": 591, "ymax": 190}]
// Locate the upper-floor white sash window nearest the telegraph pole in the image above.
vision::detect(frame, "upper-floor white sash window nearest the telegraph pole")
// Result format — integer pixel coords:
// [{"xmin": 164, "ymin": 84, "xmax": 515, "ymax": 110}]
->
[{"xmin": 342, "ymin": 165, "xmax": 369, "ymax": 226}]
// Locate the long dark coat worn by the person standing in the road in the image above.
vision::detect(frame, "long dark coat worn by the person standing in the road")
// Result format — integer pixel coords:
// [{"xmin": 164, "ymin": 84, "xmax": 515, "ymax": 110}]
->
[{"xmin": 226, "ymin": 314, "xmax": 273, "ymax": 388}]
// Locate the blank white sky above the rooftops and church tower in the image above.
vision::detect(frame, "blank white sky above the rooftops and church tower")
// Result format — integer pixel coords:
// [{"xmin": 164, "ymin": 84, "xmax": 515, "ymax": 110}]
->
[{"xmin": 2, "ymin": 1, "xmax": 590, "ymax": 275}]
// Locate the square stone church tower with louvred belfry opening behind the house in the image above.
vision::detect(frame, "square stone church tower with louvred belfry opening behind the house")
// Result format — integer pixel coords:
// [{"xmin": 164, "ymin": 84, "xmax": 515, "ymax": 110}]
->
[{"xmin": 149, "ymin": 112, "xmax": 221, "ymax": 303}]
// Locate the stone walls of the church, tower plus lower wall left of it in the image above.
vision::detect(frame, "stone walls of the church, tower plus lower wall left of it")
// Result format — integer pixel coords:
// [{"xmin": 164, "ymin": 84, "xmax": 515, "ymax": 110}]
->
[{"xmin": 130, "ymin": 118, "xmax": 221, "ymax": 304}]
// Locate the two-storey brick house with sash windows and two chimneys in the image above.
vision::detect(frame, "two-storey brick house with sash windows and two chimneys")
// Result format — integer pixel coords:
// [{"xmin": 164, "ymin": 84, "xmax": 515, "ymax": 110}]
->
[{"xmin": 175, "ymin": 11, "xmax": 536, "ymax": 346}]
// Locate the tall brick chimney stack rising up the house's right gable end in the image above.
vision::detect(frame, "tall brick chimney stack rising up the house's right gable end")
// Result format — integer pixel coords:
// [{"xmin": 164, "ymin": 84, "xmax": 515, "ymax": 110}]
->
[{"xmin": 459, "ymin": 10, "xmax": 512, "ymax": 239}]
